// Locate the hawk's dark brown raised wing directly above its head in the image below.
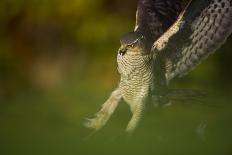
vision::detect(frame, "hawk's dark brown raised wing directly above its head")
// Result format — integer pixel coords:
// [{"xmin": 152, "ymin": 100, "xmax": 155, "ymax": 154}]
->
[{"xmin": 135, "ymin": 0, "xmax": 181, "ymax": 41}]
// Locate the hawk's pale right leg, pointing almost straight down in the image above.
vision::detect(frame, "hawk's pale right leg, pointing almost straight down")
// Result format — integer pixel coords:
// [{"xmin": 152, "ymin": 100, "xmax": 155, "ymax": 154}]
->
[{"xmin": 126, "ymin": 99, "xmax": 145, "ymax": 133}]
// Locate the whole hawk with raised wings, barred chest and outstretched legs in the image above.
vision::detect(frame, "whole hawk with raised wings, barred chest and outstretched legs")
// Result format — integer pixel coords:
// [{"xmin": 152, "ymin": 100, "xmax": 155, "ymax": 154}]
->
[{"xmin": 85, "ymin": 0, "xmax": 232, "ymax": 132}]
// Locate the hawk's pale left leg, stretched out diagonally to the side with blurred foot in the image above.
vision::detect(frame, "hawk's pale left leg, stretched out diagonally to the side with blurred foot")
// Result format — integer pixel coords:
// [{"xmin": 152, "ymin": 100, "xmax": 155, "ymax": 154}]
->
[{"xmin": 85, "ymin": 88, "xmax": 122, "ymax": 130}]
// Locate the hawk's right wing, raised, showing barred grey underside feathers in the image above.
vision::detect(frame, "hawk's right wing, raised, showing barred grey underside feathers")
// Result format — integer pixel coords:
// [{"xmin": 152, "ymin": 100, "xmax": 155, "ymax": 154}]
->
[{"xmin": 152, "ymin": 0, "xmax": 232, "ymax": 81}]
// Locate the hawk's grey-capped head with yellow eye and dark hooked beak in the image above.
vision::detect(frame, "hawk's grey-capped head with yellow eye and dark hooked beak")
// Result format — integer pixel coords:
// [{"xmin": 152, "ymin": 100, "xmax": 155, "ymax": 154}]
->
[{"xmin": 118, "ymin": 32, "xmax": 147, "ymax": 55}]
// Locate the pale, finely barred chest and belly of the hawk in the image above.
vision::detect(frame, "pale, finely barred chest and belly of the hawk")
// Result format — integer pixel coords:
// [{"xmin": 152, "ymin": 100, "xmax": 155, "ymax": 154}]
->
[{"xmin": 118, "ymin": 53, "xmax": 152, "ymax": 104}]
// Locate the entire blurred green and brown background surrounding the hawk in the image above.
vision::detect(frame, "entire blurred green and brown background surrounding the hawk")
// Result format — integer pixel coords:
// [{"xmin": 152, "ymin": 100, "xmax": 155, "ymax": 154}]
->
[{"xmin": 0, "ymin": 0, "xmax": 232, "ymax": 155}]
